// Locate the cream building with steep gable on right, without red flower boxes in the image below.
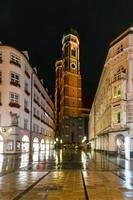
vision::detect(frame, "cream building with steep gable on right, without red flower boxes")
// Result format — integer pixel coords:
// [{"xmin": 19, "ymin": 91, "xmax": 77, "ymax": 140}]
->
[{"xmin": 89, "ymin": 27, "xmax": 133, "ymax": 159}]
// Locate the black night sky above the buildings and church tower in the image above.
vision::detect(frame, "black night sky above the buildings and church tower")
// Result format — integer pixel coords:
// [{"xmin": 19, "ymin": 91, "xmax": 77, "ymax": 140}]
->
[{"xmin": 0, "ymin": 0, "xmax": 133, "ymax": 104}]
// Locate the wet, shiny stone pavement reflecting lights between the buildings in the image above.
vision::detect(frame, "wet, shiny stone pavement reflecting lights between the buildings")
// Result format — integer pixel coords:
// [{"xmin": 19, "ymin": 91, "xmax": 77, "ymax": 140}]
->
[{"xmin": 0, "ymin": 149, "xmax": 133, "ymax": 200}]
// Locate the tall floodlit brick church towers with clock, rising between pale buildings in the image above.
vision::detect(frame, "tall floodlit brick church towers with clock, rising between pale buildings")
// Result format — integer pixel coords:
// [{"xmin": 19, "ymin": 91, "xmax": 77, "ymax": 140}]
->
[{"xmin": 55, "ymin": 29, "xmax": 84, "ymax": 144}]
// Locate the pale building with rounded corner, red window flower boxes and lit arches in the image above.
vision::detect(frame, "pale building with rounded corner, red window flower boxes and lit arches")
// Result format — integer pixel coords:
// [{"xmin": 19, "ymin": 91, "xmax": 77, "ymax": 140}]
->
[{"xmin": 0, "ymin": 45, "xmax": 55, "ymax": 153}]
